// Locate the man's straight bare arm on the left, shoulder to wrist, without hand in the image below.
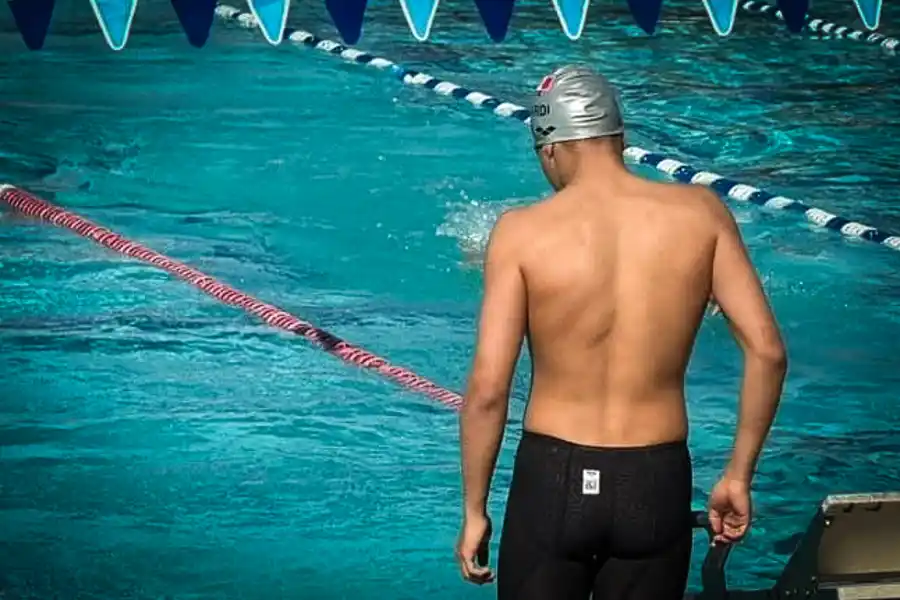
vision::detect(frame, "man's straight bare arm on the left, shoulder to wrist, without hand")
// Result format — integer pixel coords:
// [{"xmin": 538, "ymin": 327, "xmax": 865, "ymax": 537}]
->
[{"xmin": 459, "ymin": 213, "xmax": 527, "ymax": 518}]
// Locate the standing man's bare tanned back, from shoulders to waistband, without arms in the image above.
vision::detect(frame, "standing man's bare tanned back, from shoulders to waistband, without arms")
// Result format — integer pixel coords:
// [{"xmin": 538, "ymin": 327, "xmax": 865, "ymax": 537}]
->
[{"xmin": 516, "ymin": 177, "xmax": 718, "ymax": 446}]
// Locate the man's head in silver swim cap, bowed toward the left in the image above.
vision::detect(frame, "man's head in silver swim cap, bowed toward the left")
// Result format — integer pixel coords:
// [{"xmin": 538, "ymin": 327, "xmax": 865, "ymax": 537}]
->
[{"xmin": 531, "ymin": 65, "xmax": 625, "ymax": 189}]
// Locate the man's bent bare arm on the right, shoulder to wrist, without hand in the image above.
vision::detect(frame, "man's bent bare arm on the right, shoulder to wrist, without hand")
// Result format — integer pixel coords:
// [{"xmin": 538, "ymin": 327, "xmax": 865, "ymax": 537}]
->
[{"xmin": 709, "ymin": 193, "xmax": 787, "ymax": 485}]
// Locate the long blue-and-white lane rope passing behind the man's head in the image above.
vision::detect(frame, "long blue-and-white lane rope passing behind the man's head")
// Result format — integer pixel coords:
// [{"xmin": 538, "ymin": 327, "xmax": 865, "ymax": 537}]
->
[{"xmin": 216, "ymin": 4, "xmax": 900, "ymax": 250}]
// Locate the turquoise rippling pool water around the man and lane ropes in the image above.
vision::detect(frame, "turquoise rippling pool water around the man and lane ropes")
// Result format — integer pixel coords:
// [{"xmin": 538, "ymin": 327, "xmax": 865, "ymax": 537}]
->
[{"xmin": 0, "ymin": 2, "xmax": 900, "ymax": 600}]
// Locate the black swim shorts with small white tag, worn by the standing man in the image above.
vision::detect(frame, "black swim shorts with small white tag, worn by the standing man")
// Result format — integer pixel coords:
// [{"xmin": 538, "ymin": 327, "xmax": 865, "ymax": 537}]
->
[{"xmin": 497, "ymin": 431, "xmax": 693, "ymax": 600}]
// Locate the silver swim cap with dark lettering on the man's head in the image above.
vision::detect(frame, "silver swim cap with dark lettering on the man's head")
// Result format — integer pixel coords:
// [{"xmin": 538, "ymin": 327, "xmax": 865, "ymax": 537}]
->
[{"xmin": 531, "ymin": 65, "xmax": 625, "ymax": 148}]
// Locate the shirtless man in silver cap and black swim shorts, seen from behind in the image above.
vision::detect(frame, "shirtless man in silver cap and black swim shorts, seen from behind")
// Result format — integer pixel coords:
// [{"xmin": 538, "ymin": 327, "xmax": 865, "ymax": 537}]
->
[{"xmin": 457, "ymin": 66, "xmax": 786, "ymax": 600}]
